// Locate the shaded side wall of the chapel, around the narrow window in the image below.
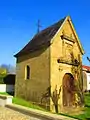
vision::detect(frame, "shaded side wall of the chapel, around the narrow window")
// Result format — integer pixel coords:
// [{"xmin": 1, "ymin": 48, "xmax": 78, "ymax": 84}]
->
[{"xmin": 15, "ymin": 47, "xmax": 50, "ymax": 106}]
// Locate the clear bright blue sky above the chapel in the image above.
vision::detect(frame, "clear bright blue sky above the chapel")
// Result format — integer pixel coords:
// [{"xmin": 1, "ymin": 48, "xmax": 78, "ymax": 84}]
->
[{"xmin": 0, "ymin": 0, "xmax": 90, "ymax": 65}]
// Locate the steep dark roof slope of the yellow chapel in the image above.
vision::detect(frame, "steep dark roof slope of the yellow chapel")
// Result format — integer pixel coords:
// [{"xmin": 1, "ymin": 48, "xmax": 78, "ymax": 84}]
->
[{"xmin": 15, "ymin": 18, "xmax": 65, "ymax": 57}]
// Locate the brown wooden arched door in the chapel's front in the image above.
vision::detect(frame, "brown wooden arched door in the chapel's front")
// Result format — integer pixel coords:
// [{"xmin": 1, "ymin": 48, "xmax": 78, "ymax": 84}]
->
[{"xmin": 62, "ymin": 73, "xmax": 75, "ymax": 106}]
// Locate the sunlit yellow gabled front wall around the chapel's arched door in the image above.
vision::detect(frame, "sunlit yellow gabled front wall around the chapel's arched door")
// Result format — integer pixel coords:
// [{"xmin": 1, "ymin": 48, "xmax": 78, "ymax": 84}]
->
[{"xmin": 50, "ymin": 17, "xmax": 82, "ymax": 112}]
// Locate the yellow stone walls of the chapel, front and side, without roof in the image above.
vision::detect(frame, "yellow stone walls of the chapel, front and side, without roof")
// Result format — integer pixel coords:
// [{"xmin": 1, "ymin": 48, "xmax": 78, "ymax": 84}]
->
[{"xmin": 15, "ymin": 17, "xmax": 84, "ymax": 111}]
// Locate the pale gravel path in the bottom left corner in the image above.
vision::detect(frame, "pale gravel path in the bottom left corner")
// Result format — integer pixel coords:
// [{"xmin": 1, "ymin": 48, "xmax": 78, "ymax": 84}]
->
[{"xmin": 0, "ymin": 107, "xmax": 40, "ymax": 120}]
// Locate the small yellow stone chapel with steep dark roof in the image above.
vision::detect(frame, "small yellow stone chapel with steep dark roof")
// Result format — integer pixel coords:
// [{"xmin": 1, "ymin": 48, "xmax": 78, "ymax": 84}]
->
[{"xmin": 15, "ymin": 16, "xmax": 84, "ymax": 112}]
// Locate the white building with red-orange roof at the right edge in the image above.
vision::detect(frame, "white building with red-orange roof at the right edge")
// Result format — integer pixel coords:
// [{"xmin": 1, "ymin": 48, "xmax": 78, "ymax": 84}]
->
[{"xmin": 82, "ymin": 65, "xmax": 90, "ymax": 91}]
